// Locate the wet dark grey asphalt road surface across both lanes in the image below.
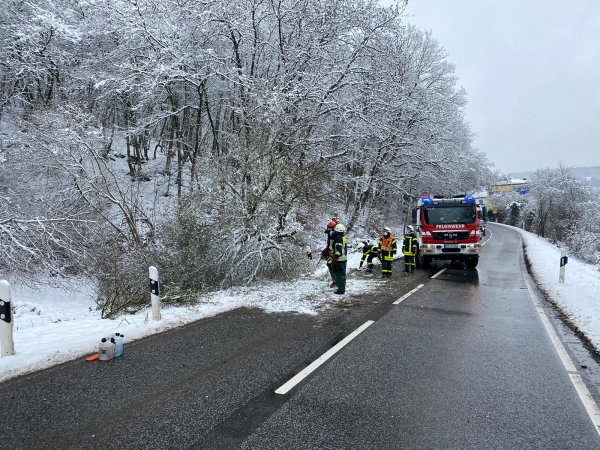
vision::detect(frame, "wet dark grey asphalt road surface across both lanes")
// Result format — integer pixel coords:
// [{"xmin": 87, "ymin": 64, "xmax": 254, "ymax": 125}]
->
[{"xmin": 0, "ymin": 223, "xmax": 600, "ymax": 449}]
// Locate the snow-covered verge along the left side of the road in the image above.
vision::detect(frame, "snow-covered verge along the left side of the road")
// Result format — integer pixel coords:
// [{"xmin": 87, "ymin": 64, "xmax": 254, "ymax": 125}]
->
[{"xmin": 0, "ymin": 253, "xmax": 370, "ymax": 382}]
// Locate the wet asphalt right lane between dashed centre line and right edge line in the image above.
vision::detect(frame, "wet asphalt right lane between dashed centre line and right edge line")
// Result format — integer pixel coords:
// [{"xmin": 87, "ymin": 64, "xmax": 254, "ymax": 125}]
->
[{"xmin": 243, "ymin": 226, "xmax": 600, "ymax": 449}]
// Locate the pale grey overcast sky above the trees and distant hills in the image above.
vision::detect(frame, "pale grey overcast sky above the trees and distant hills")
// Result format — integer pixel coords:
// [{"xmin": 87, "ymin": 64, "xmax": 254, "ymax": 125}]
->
[{"xmin": 380, "ymin": 0, "xmax": 600, "ymax": 173}]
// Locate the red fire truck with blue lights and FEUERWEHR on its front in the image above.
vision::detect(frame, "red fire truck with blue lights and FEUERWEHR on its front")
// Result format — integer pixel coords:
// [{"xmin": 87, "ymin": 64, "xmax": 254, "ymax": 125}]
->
[{"xmin": 413, "ymin": 195, "xmax": 481, "ymax": 269}]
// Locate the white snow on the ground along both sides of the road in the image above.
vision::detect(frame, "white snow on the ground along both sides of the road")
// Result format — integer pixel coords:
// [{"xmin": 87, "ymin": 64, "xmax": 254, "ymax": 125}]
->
[{"xmin": 0, "ymin": 228, "xmax": 600, "ymax": 382}]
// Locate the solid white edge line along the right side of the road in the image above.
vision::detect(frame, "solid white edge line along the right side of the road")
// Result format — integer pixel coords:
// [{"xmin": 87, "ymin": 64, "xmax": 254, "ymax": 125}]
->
[{"xmin": 524, "ymin": 275, "xmax": 600, "ymax": 435}]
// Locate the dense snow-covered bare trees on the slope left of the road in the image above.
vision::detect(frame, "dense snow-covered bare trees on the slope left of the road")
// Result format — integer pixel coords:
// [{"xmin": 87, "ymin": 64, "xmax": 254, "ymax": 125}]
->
[{"xmin": 0, "ymin": 0, "xmax": 496, "ymax": 312}]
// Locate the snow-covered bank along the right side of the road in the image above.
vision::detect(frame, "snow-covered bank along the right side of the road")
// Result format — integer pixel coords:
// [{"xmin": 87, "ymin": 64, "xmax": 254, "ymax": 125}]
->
[{"xmin": 504, "ymin": 225, "xmax": 600, "ymax": 350}]
